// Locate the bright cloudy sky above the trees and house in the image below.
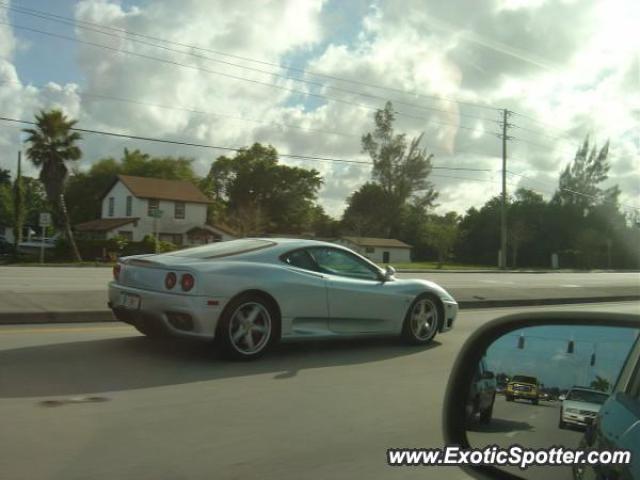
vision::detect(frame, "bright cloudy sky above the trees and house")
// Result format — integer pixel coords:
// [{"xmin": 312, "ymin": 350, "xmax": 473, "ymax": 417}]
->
[{"xmin": 0, "ymin": 0, "xmax": 640, "ymax": 217}]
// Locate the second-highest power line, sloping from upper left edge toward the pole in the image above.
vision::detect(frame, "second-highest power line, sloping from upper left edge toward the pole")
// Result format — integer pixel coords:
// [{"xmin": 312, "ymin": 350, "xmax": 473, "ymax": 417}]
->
[{"xmin": 0, "ymin": 21, "xmax": 490, "ymax": 131}]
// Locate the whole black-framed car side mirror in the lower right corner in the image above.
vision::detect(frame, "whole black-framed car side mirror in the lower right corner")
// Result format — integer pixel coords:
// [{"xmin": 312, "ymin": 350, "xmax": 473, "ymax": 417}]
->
[{"xmin": 443, "ymin": 312, "xmax": 640, "ymax": 480}]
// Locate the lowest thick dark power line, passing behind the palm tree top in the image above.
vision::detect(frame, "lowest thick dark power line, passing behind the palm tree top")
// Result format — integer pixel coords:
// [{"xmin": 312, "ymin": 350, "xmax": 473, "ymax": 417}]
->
[{"xmin": 0, "ymin": 116, "xmax": 490, "ymax": 172}]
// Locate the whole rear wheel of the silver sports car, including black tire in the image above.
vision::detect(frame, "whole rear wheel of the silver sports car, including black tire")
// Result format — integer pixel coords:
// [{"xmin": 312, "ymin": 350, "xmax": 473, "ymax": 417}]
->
[{"xmin": 216, "ymin": 293, "xmax": 280, "ymax": 360}]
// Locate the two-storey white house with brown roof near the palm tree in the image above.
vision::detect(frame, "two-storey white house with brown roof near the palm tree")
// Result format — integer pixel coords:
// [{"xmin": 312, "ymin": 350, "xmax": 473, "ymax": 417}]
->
[{"xmin": 75, "ymin": 175, "xmax": 236, "ymax": 246}]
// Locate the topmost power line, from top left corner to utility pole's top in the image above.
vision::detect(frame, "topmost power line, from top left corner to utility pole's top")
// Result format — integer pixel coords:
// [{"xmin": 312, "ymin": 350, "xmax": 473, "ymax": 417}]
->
[{"xmin": 0, "ymin": 2, "xmax": 499, "ymax": 111}]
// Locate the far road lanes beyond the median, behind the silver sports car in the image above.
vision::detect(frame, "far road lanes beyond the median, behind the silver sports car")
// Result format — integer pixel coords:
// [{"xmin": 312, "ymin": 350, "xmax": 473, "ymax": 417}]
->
[{"xmin": 0, "ymin": 267, "xmax": 640, "ymax": 316}]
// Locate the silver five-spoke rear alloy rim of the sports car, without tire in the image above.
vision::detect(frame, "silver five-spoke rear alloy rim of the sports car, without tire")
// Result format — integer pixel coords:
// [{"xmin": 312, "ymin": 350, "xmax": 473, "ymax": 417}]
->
[{"xmin": 228, "ymin": 302, "xmax": 271, "ymax": 355}]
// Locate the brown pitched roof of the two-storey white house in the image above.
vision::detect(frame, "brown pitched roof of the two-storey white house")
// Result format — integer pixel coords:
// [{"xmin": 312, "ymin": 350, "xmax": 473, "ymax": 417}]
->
[{"xmin": 103, "ymin": 175, "xmax": 211, "ymax": 203}]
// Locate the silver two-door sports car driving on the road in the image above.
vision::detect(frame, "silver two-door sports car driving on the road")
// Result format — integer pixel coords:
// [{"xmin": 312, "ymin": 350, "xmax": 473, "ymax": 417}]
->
[{"xmin": 109, "ymin": 238, "xmax": 458, "ymax": 359}]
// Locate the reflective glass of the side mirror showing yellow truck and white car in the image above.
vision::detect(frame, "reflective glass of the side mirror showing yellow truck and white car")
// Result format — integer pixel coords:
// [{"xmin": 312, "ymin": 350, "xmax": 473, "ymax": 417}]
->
[{"xmin": 465, "ymin": 325, "xmax": 640, "ymax": 480}]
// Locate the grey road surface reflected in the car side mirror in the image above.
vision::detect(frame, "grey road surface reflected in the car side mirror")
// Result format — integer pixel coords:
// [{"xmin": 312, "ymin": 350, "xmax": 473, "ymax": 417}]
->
[{"xmin": 467, "ymin": 395, "xmax": 584, "ymax": 480}]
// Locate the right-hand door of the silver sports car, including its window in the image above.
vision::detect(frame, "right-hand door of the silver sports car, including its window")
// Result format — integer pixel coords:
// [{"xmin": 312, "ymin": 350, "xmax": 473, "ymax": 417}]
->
[{"xmin": 309, "ymin": 247, "xmax": 408, "ymax": 334}]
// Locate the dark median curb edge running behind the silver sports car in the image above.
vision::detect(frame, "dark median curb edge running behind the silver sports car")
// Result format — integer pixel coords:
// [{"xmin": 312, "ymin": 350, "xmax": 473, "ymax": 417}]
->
[{"xmin": 0, "ymin": 295, "xmax": 640, "ymax": 325}]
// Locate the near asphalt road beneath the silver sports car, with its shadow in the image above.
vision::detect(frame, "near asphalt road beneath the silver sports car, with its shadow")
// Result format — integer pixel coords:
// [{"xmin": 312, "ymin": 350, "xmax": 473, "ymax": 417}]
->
[{"xmin": 0, "ymin": 302, "xmax": 639, "ymax": 480}]
